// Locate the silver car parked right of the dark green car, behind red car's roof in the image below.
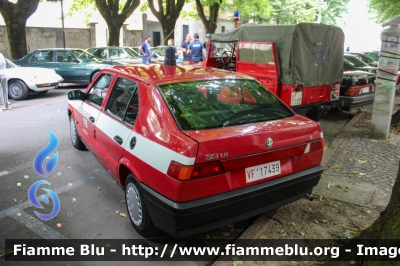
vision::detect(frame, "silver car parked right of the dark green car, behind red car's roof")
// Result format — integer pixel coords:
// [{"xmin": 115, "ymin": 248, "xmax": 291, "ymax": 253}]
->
[{"xmin": 86, "ymin": 46, "xmax": 142, "ymax": 64}]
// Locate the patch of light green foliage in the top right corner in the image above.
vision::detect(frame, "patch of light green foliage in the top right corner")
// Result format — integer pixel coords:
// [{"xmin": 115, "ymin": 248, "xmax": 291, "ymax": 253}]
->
[{"xmin": 369, "ymin": 0, "xmax": 400, "ymax": 23}]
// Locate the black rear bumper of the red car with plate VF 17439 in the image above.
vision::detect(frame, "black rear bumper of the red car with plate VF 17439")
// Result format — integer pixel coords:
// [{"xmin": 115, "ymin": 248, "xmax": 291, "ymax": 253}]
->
[{"xmin": 141, "ymin": 166, "xmax": 323, "ymax": 238}]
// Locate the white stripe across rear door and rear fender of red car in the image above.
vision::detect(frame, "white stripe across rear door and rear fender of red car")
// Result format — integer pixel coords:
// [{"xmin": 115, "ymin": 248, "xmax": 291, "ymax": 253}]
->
[{"xmin": 96, "ymin": 113, "xmax": 196, "ymax": 174}]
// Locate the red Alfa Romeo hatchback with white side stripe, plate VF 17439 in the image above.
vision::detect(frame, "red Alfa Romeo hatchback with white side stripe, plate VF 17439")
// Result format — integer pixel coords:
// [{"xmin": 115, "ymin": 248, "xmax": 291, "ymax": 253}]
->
[{"xmin": 68, "ymin": 65, "xmax": 324, "ymax": 237}]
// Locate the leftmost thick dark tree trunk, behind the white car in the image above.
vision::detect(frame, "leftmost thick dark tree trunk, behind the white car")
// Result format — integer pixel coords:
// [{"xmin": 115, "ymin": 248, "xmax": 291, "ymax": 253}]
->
[{"xmin": 0, "ymin": 0, "xmax": 39, "ymax": 59}]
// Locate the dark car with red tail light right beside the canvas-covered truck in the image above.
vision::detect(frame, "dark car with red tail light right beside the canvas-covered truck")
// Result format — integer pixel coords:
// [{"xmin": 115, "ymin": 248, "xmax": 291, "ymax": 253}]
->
[{"xmin": 339, "ymin": 71, "xmax": 376, "ymax": 111}]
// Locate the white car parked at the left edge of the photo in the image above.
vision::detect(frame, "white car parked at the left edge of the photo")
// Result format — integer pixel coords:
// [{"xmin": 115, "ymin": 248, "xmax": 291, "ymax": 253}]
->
[{"xmin": 4, "ymin": 59, "xmax": 62, "ymax": 100}]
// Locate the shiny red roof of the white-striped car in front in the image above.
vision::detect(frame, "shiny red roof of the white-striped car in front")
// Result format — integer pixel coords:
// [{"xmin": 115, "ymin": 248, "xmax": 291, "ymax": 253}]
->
[{"xmin": 107, "ymin": 64, "xmax": 253, "ymax": 84}]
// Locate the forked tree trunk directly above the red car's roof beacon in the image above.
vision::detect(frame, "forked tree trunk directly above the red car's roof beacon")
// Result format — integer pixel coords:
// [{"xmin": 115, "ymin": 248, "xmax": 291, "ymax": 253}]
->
[{"xmin": 147, "ymin": 0, "xmax": 185, "ymax": 44}]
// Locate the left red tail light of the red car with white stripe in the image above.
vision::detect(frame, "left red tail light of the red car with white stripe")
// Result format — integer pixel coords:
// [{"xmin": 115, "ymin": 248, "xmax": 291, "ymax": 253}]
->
[{"xmin": 167, "ymin": 161, "xmax": 224, "ymax": 181}]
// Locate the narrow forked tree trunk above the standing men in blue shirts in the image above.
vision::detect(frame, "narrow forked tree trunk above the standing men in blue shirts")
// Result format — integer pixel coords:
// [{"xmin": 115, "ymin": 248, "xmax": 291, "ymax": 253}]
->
[{"xmin": 195, "ymin": 0, "xmax": 223, "ymax": 33}]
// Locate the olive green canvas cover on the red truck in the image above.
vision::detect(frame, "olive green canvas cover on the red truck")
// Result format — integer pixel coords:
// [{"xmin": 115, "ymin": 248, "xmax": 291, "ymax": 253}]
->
[{"xmin": 212, "ymin": 23, "xmax": 344, "ymax": 86}]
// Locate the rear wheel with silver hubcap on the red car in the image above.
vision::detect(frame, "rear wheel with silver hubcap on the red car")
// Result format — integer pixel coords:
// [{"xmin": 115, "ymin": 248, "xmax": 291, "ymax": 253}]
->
[{"xmin": 125, "ymin": 174, "xmax": 158, "ymax": 236}]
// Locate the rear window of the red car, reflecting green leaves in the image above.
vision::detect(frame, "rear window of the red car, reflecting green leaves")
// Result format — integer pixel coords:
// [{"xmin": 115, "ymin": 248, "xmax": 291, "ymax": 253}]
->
[{"xmin": 159, "ymin": 80, "xmax": 294, "ymax": 130}]
